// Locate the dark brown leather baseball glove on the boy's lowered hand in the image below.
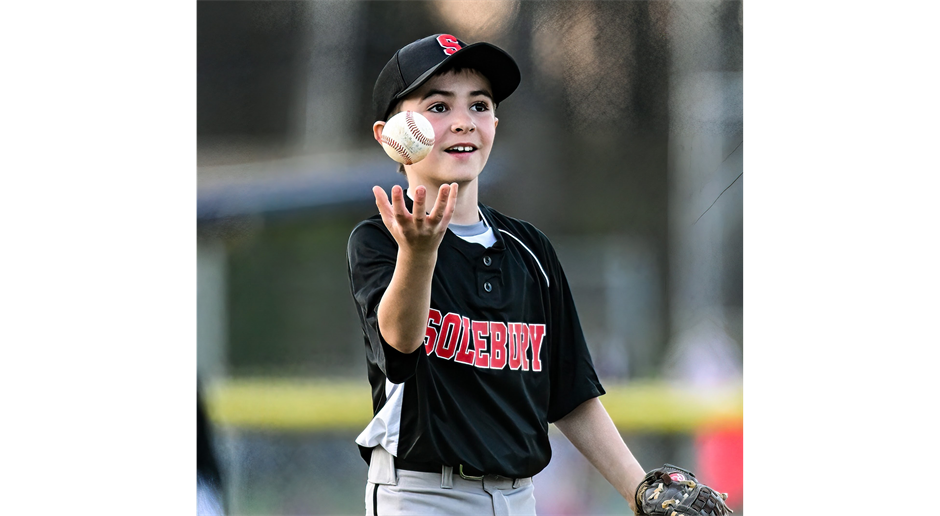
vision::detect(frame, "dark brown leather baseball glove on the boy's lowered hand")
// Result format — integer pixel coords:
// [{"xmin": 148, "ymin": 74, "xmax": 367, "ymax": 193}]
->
[{"xmin": 636, "ymin": 464, "xmax": 734, "ymax": 516}]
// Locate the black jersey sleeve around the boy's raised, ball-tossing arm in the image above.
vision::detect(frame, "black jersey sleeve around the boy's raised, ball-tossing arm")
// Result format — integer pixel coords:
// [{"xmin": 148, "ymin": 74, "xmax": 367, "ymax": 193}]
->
[{"xmin": 347, "ymin": 221, "xmax": 424, "ymax": 384}]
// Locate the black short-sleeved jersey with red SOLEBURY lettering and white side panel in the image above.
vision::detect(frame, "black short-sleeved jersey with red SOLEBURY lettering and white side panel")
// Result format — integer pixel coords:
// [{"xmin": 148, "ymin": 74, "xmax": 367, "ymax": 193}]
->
[{"xmin": 348, "ymin": 197, "xmax": 605, "ymax": 478}]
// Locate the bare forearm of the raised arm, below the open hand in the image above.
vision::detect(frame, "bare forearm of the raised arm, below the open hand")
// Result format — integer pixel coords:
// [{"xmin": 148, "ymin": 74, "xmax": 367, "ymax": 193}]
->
[{"xmin": 378, "ymin": 249, "xmax": 437, "ymax": 354}]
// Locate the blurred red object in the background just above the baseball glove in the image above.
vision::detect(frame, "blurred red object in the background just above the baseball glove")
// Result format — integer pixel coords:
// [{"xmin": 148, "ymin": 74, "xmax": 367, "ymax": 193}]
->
[{"xmin": 695, "ymin": 428, "xmax": 744, "ymax": 510}]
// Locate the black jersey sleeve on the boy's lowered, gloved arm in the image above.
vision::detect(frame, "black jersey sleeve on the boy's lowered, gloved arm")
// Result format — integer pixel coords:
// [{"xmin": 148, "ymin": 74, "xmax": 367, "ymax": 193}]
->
[{"xmin": 539, "ymin": 233, "xmax": 607, "ymax": 423}]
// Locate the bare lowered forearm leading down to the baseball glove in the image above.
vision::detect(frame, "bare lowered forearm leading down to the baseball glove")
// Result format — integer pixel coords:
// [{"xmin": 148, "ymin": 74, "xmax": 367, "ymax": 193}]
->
[{"xmin": 555, "ymin": 398, "xmax": 646, "ymax": 512}]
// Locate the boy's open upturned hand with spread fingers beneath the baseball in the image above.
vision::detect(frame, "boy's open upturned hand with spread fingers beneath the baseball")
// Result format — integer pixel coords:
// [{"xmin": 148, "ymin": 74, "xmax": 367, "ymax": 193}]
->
[{"xmin": 372, "ymin": 183, "xmax": 458, "ymax": 253}]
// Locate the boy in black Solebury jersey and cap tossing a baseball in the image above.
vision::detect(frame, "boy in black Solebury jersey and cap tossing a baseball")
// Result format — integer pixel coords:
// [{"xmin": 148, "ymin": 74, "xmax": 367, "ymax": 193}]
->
[{"xmin": 348, "ymin": 34, "xmax": 645, "ymax": 516}]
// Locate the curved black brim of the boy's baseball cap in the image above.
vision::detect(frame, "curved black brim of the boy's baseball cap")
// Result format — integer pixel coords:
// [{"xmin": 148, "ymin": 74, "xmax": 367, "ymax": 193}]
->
[{"xmin": 395, "ymin": 43, "xmax": 522, "ymax": 104}]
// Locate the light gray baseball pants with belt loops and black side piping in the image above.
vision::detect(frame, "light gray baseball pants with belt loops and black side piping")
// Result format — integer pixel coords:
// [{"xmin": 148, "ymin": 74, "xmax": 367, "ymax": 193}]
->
[{"xmin": 365, "ymin": 446, "xmax": 535, "ymax": 516}]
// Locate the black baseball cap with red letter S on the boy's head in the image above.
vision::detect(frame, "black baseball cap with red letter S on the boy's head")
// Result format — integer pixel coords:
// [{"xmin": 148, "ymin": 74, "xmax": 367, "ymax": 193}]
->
[{"xmin": 372, "ymin": 34, "xmax": 522, "ymax": 121}]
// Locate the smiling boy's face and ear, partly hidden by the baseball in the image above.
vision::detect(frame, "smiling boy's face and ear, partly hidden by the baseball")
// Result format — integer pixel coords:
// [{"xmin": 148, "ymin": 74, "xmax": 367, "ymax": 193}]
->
[{"xmin": 375, "ymin": 70, "xmax": 499, "ymax": 187}]
